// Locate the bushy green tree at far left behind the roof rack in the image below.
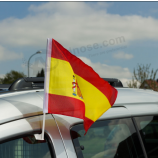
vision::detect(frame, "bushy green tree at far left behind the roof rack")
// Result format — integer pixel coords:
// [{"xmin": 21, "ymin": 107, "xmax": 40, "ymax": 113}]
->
[{"xmin": 0, "ymin": 70, "xmax": 26, "ymax": 84}]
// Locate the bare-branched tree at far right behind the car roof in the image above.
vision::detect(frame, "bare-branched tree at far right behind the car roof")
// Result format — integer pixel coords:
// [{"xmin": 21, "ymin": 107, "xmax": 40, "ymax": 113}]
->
[{"xmin": 127, "ymin": 64, "xmax": 158, "ymax": 88}]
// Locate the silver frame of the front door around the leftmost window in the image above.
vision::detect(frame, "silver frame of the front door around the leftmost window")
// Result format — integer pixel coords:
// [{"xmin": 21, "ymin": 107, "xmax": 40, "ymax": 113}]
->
[{"xmin": 0, "ymin": 114, "xmax": 67, "ymax": 158}]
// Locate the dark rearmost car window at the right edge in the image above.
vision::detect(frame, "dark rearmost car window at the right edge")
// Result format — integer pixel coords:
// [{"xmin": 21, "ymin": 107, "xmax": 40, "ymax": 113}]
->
[{"xmin": 135, "ymin": 116, "xmax": 158, "ymax": 158}]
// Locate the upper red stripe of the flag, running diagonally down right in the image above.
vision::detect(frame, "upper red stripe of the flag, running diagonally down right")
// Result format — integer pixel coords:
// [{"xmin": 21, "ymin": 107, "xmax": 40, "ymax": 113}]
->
[{"xmin": 51, "ymin": 39, "xmax": 117, "ymax": 106}]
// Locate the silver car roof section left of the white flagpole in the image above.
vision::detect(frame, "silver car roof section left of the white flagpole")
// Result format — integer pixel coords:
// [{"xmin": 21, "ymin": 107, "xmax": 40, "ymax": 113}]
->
[{"xmin": 0, "ymin": 92, "xmax": 43, "ymax": 124}]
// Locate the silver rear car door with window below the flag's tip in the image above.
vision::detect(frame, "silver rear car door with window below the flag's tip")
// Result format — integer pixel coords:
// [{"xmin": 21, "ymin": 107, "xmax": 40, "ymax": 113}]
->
[{"xmin": 54, "ymin": 107, "xmax": 146, "ymax": 158}]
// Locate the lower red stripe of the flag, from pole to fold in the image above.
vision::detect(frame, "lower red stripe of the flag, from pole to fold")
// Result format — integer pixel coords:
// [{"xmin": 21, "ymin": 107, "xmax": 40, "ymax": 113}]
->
[{"xmin": 48, "ymin": 94, "xmax": 85, "ymax": 119}]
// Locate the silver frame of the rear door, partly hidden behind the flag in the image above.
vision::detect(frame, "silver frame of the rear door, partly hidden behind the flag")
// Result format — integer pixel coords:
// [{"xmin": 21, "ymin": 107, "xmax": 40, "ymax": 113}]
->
[{"xmin": 54, "ymin": 107, "xmax": 130, "ymax": 158}]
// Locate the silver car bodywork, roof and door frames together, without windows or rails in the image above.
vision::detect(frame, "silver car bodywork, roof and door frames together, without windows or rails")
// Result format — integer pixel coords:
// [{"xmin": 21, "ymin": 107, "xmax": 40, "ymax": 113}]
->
[{"xmin": 0, "ymin": 88, "xmax": 158, "ymax": 158}]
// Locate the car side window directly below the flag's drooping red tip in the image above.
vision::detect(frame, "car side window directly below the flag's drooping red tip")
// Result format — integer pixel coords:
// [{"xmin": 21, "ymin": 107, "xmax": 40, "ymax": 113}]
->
[{"xmin": 71, "ymin": 118, "xmax": 144, "ymax": 158}]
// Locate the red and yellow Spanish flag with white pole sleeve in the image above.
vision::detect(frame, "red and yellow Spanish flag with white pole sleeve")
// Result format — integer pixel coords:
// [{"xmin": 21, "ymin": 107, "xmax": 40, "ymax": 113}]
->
[{"xmin": 43, "ymin": 38, "xmax": 117, "ymax": 132}]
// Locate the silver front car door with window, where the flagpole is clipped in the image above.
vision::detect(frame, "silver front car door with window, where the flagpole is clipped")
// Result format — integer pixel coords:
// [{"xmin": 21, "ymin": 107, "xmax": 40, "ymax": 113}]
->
[{"xmin": 0, "ymin": 114, "xmax": 67, "ymax": 158}]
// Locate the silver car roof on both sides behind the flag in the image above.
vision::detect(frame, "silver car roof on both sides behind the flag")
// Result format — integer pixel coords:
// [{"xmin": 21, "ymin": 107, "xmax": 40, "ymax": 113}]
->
[{"xmin": 0, "ymin": 88, "xmax": 158, "ymax": 124}]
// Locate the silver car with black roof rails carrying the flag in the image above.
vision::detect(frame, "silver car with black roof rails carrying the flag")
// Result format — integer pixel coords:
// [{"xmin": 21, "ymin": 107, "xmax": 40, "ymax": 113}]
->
[{"xmin": 0, "ymin": 78, "xmax": 158, "ymax": 158}]
